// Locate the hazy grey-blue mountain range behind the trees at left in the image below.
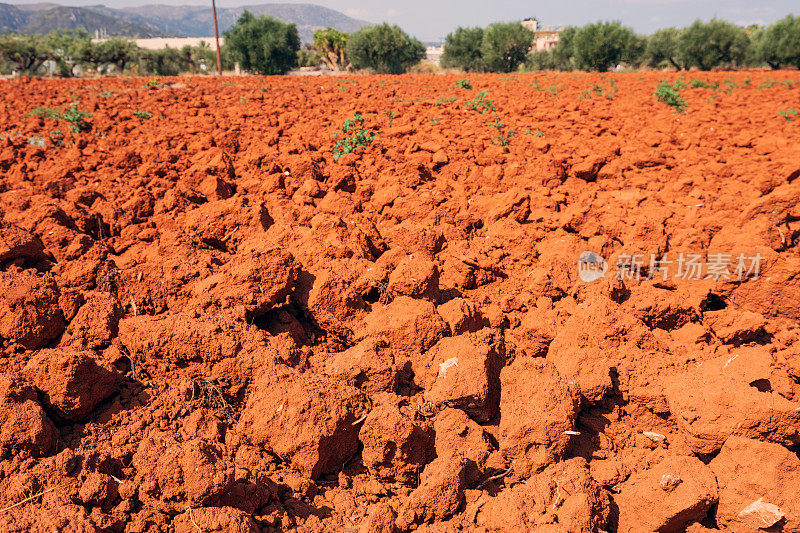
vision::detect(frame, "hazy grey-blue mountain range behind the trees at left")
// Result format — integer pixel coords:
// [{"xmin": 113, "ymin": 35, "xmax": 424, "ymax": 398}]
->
[{"xmin": 0, "ymin": 3, "xmax": 370, "ymax": 42}]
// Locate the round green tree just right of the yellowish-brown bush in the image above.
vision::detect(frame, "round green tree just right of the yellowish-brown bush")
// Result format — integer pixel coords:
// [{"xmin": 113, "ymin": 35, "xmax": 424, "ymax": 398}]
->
[{"xmin": 346, "ymin": 24, "xmax": 425, "ymax": 74}]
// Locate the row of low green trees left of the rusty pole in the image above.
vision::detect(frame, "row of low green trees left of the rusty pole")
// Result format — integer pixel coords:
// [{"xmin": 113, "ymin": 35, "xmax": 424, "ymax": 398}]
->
[{"xmin": 0, "ymin": 30, "xmax": 215, "ymax": 77}]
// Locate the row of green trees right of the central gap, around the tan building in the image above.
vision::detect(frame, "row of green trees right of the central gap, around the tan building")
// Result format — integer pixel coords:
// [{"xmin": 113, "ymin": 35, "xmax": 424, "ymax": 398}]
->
[{"xmin": 442, "ymin": 15, "xmax": 800, "ymax": 72}]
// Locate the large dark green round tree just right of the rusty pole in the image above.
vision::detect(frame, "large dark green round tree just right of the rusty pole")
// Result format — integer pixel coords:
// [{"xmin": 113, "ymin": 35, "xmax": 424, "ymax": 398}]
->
[{"xmin": 225, "ymin": 11, "xmax": 300, "ymax": 74}]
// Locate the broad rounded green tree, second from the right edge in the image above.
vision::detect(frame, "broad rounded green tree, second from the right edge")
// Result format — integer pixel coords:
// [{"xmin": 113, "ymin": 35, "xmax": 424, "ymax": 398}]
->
[{"xmin": 678, "ymin": 19, "xmax": 750, "ymax": 70}]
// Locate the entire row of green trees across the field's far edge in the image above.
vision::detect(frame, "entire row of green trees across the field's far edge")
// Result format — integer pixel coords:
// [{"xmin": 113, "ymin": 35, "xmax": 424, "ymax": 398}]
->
[{"xmin": 0, "ymin": 11, "xmax": 800, "ymax": 76}]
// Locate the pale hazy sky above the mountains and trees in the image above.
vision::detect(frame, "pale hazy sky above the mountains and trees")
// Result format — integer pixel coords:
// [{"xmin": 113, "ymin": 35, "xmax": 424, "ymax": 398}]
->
[{"xmin": 4, "ymin": 0, "xmax": 800, "ymax": 41}]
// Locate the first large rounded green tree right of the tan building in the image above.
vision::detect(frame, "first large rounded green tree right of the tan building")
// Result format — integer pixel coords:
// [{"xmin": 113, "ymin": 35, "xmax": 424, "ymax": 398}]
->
[{"xmin": 574, "ymin": 22, "xmax": 640, "ymax": 72}]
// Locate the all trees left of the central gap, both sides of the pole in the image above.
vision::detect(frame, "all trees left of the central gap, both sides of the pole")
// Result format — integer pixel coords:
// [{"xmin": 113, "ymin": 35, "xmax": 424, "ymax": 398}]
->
[{"xmin": 0, "ymin": 11, "xmax": 425, "ymax": 76}]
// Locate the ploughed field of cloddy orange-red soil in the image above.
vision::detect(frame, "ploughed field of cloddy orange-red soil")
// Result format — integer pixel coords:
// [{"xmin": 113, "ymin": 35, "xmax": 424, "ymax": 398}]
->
[{"xmin": 0, "ymin": 71, "xmax": 800, "ymax": 533}]
